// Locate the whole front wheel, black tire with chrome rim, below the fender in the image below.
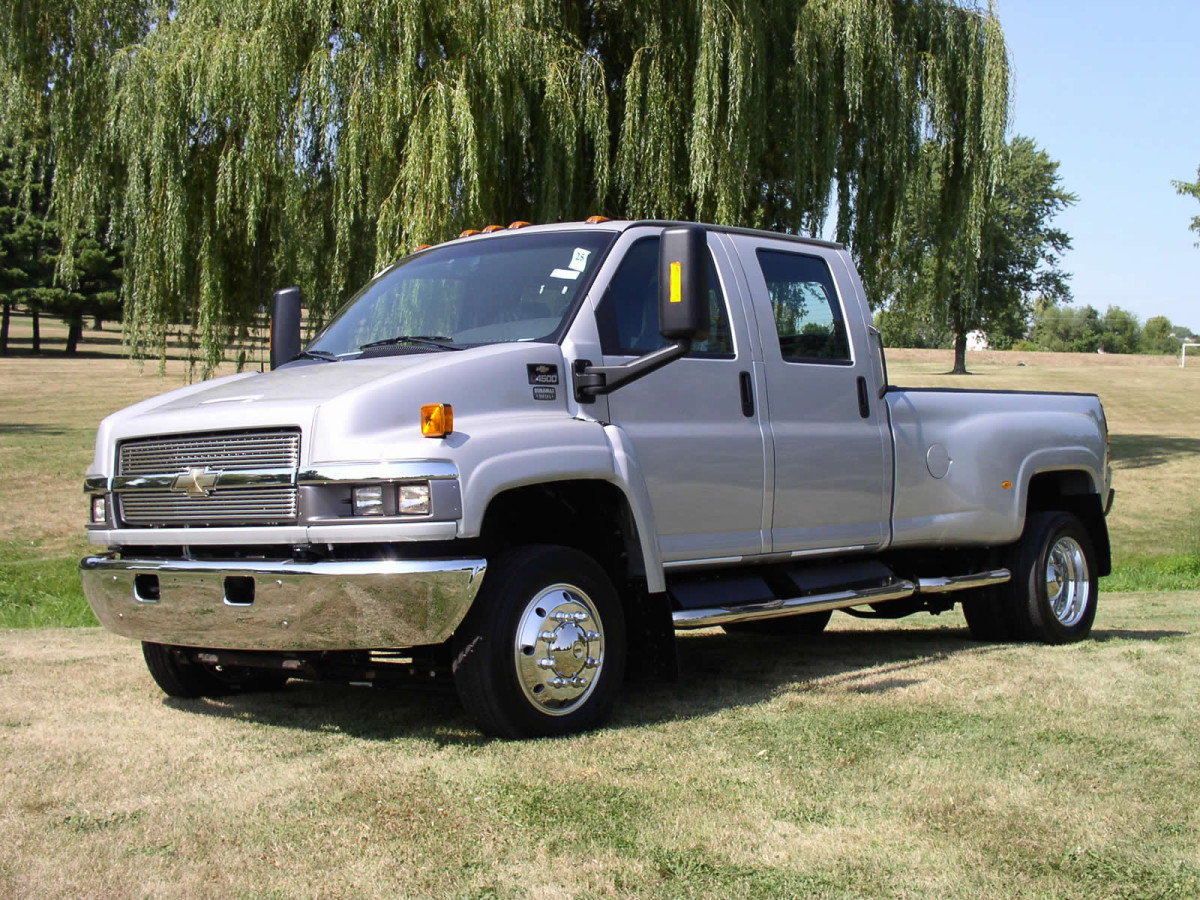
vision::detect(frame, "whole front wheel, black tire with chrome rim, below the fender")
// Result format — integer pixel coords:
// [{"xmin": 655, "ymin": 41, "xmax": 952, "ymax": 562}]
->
[{"xmin": 452, "ymin": 546, "xmax": 625, "ymax": 738}]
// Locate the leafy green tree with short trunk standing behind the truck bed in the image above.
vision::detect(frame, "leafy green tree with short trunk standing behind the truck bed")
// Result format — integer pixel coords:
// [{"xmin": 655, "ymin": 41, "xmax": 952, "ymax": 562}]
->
[{"xmin": 886, "ymin": 136, "xmax": 1076, "ymax": 374}]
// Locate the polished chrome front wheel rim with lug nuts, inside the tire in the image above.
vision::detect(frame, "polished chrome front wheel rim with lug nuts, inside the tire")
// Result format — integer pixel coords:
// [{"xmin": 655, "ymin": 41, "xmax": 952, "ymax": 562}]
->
[{"xmin": 514, "ymin": 584, "xmax": 605, "ymax": 715}]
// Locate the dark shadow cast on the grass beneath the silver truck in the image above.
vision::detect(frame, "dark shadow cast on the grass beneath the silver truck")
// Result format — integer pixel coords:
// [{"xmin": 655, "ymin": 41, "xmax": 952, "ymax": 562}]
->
[{"xmin": 163, "ymin": 625, "xmax": 1189, "ymax": 748}]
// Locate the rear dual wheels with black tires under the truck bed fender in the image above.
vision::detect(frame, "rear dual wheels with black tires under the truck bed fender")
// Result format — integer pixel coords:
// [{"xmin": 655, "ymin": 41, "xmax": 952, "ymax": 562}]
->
[{"xmin": 962, "ymin": 511, "xmax": 1099, "ymax": 644}]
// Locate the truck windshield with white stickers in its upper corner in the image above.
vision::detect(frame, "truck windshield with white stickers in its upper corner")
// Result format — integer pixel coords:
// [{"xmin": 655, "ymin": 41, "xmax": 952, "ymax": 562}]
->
[{"xmin": 307, "ymin": 230, "xmax": 614, "ymax": 359}]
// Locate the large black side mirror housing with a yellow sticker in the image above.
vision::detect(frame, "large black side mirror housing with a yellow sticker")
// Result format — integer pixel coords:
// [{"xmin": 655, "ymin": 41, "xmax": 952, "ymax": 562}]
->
[{"xmin": 659, "ymin": 226, "xmax": 708, "ymax": 342}]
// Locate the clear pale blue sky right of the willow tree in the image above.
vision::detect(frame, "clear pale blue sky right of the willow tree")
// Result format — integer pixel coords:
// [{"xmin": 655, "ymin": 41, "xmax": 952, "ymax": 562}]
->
[{"xmin": 996, "ymin": 0, "xmax": 1200, "ymax": 332}]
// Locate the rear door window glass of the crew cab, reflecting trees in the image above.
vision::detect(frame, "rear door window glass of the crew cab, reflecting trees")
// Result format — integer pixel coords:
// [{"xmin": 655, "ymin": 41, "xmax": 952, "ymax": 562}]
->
[{"xmin": 758, "ymin": 250, "xmax": 851, "ymax": 365}]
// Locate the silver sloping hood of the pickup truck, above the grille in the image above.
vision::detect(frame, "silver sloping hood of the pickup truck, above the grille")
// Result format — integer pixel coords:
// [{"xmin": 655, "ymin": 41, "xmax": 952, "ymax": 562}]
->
[{"xmin": 89, "ymin": 342, "xmax": 566, "ymax": 475}]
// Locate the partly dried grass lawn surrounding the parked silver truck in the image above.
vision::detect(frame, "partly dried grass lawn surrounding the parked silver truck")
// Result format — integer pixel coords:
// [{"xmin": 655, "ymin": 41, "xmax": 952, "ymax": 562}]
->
[{"xmin": 0, "ymin": 336, "xmax": 1200, "ymax": 899}]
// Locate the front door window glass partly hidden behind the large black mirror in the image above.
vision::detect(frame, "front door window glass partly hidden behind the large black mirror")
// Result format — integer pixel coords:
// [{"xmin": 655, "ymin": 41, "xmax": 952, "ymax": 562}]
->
[{"xmin": 596, "ymin": 238, "xmax": 733, "ymax": 359}]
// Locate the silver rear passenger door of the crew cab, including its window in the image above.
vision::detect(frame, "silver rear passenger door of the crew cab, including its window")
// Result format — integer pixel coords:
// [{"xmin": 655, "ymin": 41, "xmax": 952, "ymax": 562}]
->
[{"xmin": 727, "ymin": 234, "xmax": 892, "ymax": 556}]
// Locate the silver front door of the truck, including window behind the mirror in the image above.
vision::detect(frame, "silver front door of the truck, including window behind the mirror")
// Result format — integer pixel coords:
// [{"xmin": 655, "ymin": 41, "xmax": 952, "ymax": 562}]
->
[{"xmin": 596, "ymin": 229, "xmax": 766, "ymax": 563}]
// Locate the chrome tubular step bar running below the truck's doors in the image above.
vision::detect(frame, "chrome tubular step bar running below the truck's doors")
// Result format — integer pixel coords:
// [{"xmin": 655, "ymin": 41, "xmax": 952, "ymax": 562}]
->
[{"xmin": 671, "ymin": 569, "xmax": 1013, "ymax": 629}]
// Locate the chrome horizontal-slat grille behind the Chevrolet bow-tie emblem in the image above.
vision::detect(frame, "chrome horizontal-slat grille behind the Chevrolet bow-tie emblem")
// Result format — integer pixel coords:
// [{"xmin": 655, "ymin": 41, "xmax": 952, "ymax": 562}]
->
[{"xmin": 118, "ymin": 431, "xmax": 300, "ymax": 527}]
